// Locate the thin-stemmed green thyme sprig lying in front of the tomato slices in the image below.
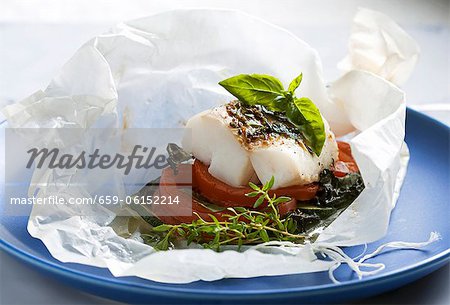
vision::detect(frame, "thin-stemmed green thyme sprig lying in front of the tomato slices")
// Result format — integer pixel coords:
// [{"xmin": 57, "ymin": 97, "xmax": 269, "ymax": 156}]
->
[{"xmin": 141, "ymin": 177, "xmax": 307, "ymax": 251}]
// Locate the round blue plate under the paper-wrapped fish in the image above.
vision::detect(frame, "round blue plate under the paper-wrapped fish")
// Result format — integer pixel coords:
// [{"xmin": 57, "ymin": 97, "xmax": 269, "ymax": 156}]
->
[{"xmin": 0, "ymin": 109, "xmax": 450, "ymax": 303}]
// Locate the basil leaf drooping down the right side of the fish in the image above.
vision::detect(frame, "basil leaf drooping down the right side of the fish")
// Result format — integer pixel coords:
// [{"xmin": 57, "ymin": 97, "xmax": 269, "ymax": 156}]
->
[{"xmin": 286, "ymin": 97, "xmax": 326, "ymax": 156}]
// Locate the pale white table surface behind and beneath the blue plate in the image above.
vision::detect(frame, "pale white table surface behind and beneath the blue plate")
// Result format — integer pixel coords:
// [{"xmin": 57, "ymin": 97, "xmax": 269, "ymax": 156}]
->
[{"xmin": 0, "ymin": 0, "xmax": 450, "ymax": 304}]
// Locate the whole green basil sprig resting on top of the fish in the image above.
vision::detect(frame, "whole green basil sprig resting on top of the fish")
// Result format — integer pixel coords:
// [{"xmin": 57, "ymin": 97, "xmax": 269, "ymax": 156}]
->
[{"xmin": 219, "ymin": 74, "xmax": 326, "ymax": 156}]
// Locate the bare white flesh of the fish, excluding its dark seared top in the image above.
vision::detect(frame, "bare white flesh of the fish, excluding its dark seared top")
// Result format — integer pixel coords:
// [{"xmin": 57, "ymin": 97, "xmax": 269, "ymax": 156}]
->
[{"xmin": 182, "ymin": 105, "xmax": 338, "ymax": 189}]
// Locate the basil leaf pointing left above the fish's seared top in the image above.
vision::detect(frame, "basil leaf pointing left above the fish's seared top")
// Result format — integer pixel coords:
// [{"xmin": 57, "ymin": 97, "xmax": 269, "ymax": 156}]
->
[{"xmin": 219, "ymin": 74, "xmax": 284, "ymax": 110}]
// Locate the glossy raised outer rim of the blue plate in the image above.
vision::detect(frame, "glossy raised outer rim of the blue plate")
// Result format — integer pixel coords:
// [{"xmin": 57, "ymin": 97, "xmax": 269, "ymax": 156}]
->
[{"xmin": 0, "ymin": 107, "xmax": 450, "ymax": 299}]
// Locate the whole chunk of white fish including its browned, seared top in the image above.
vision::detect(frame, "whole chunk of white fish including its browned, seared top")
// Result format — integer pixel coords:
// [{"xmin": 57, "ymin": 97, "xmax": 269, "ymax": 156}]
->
[{"xmin": 182, "ymin": 102, "xmax": 338, "ymax": 188}]
